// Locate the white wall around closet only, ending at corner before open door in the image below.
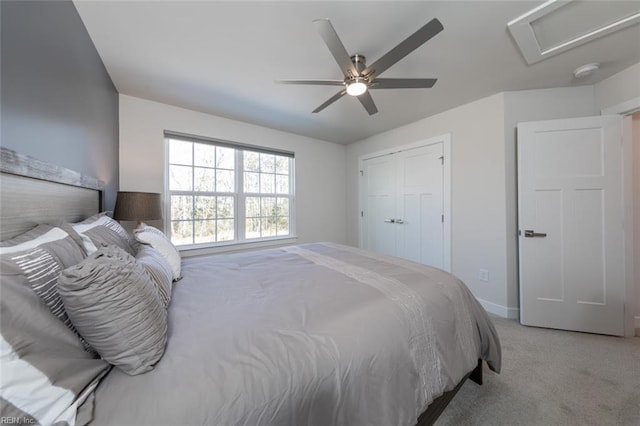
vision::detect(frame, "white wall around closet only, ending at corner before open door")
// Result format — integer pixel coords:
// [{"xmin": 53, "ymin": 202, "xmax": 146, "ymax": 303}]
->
[{"xmin": 347, "ymin": 94, "xmax": 508, "ymax": 316}]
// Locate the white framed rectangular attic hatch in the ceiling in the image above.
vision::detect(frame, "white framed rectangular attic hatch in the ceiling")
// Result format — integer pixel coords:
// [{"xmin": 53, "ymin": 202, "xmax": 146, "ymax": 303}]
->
[{"xmin": 507, "ymin": 0, "xmax": 640, "ymax": 64}]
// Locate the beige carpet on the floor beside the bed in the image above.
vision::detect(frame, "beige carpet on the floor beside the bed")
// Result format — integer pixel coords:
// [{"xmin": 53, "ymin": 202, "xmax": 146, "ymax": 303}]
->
[{"xmin": 436, "ymin": 317, "xmax": 640, "ymax": 426}]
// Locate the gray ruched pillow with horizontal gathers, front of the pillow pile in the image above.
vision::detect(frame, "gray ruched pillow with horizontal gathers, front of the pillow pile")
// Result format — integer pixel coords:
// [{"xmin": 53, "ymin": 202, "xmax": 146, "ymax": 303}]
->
[{"xmin": 58, "ymin": 246, "xmax": 167, "ymax": 375}]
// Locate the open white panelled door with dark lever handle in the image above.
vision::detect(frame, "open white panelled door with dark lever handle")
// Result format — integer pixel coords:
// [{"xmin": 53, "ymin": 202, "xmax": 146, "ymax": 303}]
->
[{"xmin": 518, "ymin": 116, "xmax": 625, "ymax": 335}]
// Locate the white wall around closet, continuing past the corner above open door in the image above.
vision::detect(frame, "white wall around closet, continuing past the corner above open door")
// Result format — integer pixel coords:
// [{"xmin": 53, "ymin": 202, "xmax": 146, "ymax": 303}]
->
[{"xmin": 347, "ymin": 86, "xmax": 598, "ymax": 318}]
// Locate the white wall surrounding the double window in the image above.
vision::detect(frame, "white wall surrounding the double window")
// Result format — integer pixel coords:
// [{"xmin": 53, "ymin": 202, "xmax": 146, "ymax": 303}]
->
[{"xmin": 120, "ymin": 95, "xmax": 346, "ymax": 243}]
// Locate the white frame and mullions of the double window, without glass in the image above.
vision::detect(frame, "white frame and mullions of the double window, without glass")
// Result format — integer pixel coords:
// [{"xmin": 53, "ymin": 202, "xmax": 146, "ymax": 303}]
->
[{"xmin": 163, "ymin": 131, "xmax": 297, "ymax": 255}]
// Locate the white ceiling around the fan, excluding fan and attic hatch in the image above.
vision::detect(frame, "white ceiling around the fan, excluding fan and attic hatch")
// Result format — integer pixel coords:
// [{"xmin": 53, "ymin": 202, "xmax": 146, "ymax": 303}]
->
[{"xmin": 74, "ymin": 0, "xmax": 640, "ymax": 143}]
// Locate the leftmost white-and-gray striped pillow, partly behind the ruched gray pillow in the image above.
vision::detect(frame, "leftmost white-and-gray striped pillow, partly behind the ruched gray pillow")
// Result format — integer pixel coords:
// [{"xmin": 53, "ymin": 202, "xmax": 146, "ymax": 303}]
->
[{"xmin": 0, "ymin": 225, "xmax": 96, "ymax": 356}]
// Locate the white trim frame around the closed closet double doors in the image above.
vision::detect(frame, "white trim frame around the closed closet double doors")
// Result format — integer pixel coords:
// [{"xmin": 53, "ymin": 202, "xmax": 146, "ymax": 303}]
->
[{"xmin": 358, "ymin": 133, "xmax": 452, "ymax": 272}]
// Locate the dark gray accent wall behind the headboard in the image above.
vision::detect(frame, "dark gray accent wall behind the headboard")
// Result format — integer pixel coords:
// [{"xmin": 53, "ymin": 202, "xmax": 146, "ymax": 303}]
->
[{"xmin": 0, "ymin": 0, "xmax": 119, "ymax": 210}]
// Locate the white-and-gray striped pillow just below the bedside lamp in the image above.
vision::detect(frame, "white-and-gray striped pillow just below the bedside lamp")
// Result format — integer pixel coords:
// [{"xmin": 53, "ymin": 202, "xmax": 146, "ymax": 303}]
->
[{"xmin": 71, "ymin": 213, "xmax": 137, "ymax": 255}]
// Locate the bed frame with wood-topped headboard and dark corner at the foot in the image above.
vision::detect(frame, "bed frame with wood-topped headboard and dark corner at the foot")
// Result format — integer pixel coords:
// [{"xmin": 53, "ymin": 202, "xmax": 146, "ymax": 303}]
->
[{"xmin": 0, "ymin": 147, "xmax": 482, "ymax": 426}]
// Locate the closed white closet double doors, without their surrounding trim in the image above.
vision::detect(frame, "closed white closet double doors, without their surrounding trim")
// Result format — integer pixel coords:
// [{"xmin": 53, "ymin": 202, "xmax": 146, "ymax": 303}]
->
[{"xmin": 362, "ymin": 143, "xmax": 444, "ymax": 268}]
